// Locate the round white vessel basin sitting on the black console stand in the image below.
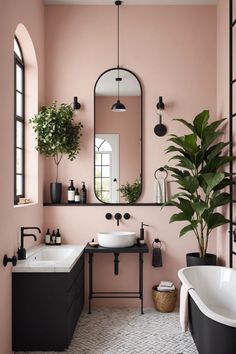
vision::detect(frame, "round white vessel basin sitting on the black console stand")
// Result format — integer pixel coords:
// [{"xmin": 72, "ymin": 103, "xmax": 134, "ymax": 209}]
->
[{"xmin": 97, "ymin": 231, "xmax": 136, "ymax": 248}]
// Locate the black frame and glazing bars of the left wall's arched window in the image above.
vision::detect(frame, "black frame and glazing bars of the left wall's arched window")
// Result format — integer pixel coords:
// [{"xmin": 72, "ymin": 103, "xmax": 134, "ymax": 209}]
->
[{"xmin": 14, "ymin": 36, "xmax": 25, "ymax": 204}]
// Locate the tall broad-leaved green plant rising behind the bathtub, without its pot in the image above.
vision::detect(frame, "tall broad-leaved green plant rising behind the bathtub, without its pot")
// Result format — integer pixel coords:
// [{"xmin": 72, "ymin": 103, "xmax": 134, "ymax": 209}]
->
[{"xmin": 165, "ymin": 110, "xmax": 234, "ymax": 257}]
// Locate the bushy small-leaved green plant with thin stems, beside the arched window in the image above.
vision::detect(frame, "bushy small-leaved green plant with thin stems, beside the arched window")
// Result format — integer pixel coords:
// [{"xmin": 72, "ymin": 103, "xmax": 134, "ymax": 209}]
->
[{"xmin": 30, "ymin": 102, "xmax": 83, "ymax": 182}]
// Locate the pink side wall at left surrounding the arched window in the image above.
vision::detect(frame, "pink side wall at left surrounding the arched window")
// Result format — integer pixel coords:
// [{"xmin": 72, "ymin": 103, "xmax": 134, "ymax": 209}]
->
[{"xmin": 0, "ymin": 0, "xmax": 44, "ymax": 354}]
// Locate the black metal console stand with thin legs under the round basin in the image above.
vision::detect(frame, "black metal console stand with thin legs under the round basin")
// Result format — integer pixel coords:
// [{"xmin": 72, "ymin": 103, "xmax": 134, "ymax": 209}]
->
[{"xmin": 84, "ymin": 244, "xmax": 148, "ymax": 314}]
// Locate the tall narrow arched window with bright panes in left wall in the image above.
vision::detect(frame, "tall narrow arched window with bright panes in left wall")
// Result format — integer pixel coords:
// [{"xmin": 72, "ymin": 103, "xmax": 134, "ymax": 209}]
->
[{"xmin": 14, "ymin": 37, "xmax": 25, "ymax": 204}]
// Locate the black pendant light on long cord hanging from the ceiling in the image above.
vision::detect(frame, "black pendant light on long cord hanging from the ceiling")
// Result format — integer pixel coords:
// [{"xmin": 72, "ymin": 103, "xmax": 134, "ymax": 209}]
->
[{"xmin": 111, "ymin": 1, "xmax": 126, "ymax": 112}]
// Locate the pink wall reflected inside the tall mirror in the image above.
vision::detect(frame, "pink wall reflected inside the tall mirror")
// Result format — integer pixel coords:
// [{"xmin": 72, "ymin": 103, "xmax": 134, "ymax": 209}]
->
[{"xmin": 95, "ymin": 96, "xmax": 141, "ymax": 191}]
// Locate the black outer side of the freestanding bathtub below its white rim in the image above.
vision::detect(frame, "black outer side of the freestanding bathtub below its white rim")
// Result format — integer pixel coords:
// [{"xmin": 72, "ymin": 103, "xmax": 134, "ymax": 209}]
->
[{"xmin": 189, "ymin": 295, "xmax": 236, "ymax": 354}]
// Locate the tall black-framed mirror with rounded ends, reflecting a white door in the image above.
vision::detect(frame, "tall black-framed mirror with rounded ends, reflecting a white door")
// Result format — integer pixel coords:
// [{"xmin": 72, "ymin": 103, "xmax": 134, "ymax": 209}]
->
[{"xmin": 94, "ymin": 68, "xmax": 142, "ymax": 203}]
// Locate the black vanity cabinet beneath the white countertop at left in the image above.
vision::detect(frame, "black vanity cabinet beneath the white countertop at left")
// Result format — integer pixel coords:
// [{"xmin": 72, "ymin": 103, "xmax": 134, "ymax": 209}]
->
[{"xmin": 12, "ymin": 255, "xmax": 84, "ymax": 351}]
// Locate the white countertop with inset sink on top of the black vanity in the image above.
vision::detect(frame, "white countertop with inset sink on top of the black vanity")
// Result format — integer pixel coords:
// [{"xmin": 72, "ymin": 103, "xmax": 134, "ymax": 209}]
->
[{"xmin": 12, "ymin": 244, "xmax": 86, "ymax": 273}]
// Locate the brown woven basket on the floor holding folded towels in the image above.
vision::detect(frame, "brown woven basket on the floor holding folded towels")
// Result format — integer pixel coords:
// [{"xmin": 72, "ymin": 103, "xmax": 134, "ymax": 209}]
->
[{"xmin": 152, "ymin": 285, "xmax": 177, "ymax": 312}]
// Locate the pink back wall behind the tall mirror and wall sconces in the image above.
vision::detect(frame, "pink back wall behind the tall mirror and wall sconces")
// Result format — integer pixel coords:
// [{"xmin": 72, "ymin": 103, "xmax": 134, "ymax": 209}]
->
[{"xmin": 44, "ymin": 2, "xmax": 216, "ymax": 306}]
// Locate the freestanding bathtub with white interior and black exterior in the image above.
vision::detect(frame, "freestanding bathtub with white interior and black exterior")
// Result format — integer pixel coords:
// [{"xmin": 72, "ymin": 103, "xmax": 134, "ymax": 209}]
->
[{"xmin": 178, "ymin": 266, "xmax": 236, "ymax": 354}]
